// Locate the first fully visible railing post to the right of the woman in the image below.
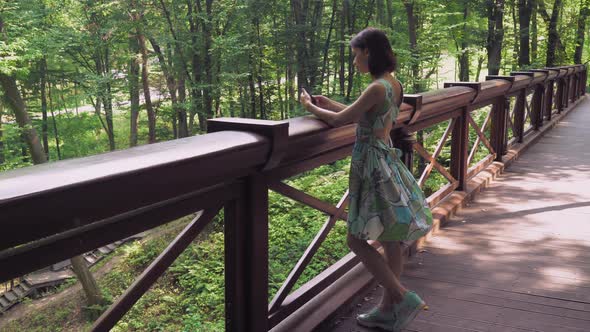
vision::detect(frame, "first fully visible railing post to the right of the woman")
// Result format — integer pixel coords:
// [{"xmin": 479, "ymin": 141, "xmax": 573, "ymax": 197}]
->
[{"xmin": 451, "ymin": 107, "xmax": 470, "ymax": 190}]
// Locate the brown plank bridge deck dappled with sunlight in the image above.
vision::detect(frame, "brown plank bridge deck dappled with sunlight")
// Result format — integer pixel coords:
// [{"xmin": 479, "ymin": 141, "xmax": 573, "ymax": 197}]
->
[{"xmin": 322, "ymin": 99, "xmax": 590, "ymax": 332}]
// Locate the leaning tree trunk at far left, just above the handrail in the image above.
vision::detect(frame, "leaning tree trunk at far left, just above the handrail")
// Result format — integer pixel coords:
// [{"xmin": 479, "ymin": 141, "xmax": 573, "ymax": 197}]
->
[{"xmin": 0, "ymin": 72, "xmax": 47, "ymax": 164}]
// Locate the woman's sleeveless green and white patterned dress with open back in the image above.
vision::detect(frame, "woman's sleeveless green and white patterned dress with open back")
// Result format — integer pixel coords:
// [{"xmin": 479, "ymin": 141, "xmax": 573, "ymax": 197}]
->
[{"xmin": 348, "ymin": 79, "xmax": 432, "ymax": 241}]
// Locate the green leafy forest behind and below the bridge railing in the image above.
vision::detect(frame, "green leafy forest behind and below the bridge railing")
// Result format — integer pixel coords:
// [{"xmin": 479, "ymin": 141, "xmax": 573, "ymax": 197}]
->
[{"xmin": 0, "ymin": 0, "xmax": 590, "ymax": 331}]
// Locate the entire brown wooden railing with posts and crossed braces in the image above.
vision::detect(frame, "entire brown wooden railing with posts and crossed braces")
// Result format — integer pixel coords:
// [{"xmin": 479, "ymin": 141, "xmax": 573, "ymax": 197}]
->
[{"xmin": 0, "ymin": 65, "xmax": 587, "ymax": 331}]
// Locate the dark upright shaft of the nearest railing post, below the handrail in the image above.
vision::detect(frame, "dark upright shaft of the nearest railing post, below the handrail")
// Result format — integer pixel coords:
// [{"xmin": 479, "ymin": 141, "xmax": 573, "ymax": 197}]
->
[{"xmin": 224, "ymin": 174, "xmax": 268, "ymax": 332}]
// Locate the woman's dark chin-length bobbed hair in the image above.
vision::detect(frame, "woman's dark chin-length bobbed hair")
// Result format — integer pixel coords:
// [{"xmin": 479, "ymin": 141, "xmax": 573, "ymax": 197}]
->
[{"xmin": 350, "ymin": 28, "xmax": 397, "ymax": 76}]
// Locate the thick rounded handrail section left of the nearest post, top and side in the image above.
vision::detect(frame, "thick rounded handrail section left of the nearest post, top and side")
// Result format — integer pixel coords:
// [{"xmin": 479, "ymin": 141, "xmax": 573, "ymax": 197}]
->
[{"xmin": 0, "ymin": 131, "xmax": 270, "ymax": 250}]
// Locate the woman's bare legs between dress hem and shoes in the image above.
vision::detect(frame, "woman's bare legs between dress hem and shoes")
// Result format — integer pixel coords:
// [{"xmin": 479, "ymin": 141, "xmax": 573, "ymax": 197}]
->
[{"xmin": 348, "ymin": 234, "xmax": 407, "ymax": 309}]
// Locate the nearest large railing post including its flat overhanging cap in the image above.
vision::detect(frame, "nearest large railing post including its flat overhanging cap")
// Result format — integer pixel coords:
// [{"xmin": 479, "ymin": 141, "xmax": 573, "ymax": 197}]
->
[{"xmin": 207, "ymin": 118, "xmax": 289, "ymax": 332}]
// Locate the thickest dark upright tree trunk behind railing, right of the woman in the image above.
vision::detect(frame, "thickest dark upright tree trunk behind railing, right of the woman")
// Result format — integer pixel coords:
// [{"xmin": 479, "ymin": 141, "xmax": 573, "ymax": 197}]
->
[{"xmin": 486, "ymin": 0, "xmax": 504, "ymax": 75}]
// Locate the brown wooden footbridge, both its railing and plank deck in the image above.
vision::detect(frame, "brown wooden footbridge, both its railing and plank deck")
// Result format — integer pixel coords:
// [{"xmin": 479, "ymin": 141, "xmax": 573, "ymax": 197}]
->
[{"xmin": 0, "ymin": 65, "xmax": 590, "ymax": 331}]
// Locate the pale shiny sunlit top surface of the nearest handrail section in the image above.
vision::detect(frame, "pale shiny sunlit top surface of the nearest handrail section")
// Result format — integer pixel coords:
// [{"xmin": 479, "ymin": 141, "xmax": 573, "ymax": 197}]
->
[{"xmin": 0, "ymin": 131, "xmax": 268, "ymax": 204}]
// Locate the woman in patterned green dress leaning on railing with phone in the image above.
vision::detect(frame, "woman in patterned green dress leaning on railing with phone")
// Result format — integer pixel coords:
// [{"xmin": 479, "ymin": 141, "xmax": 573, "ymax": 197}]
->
[{"xmin": 300, "ymin": 28, "xmax": 432, "ymax": 331}]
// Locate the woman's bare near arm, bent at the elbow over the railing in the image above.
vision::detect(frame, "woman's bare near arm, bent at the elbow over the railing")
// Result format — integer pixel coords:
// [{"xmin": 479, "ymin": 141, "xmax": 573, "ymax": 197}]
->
[{"xmin": 301, "ymin": 84, "xmax": 385, "ymax": 127}]
